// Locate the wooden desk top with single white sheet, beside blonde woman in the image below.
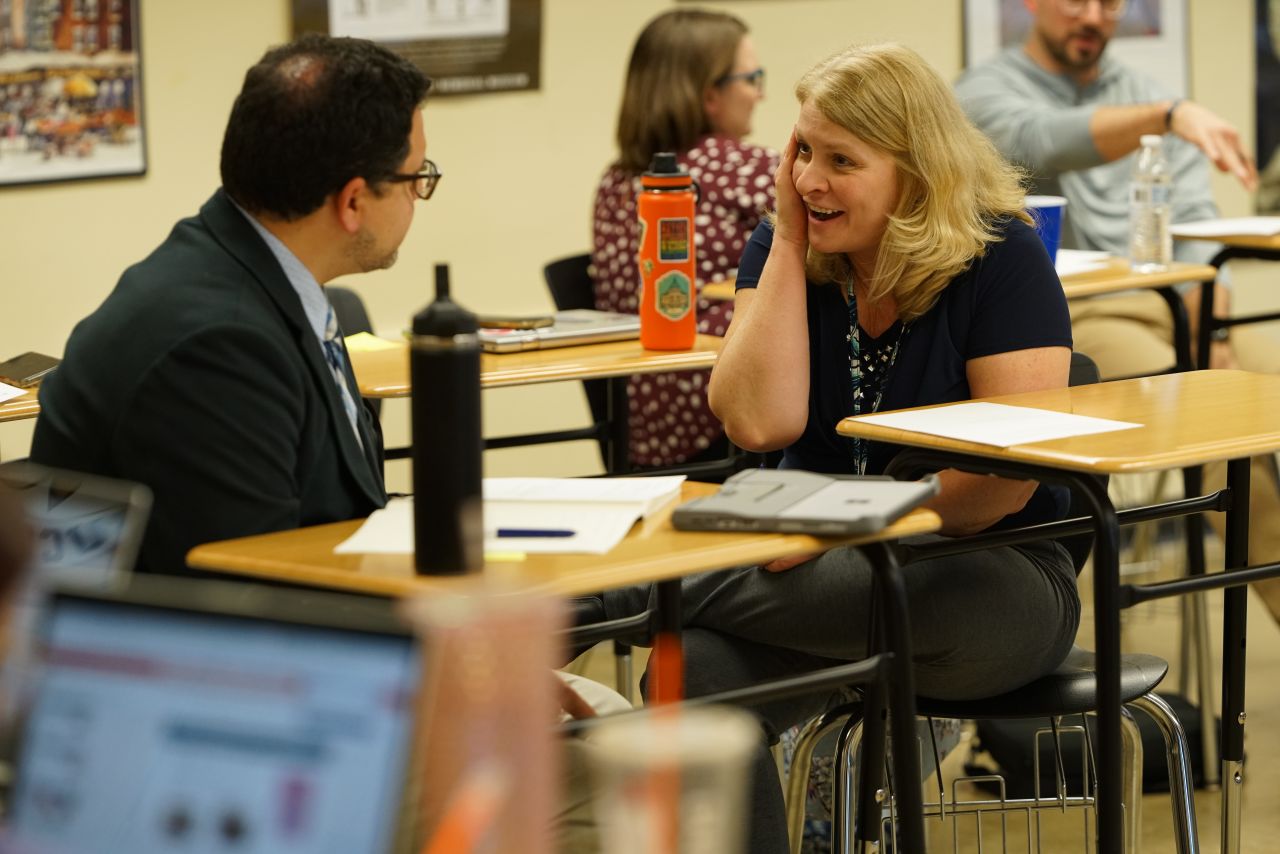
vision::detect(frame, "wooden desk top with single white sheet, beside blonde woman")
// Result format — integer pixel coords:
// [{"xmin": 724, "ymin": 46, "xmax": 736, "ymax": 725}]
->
[{"xmin": 837, "ymin": 370, "xmax": 1280, "ymax": 474}]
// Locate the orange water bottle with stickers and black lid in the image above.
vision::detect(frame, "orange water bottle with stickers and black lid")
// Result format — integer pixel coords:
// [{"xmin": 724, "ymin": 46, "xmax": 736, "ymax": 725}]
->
[{"xmin": 636, "ymin": 151, "xmax": 698, "ymax": 350}]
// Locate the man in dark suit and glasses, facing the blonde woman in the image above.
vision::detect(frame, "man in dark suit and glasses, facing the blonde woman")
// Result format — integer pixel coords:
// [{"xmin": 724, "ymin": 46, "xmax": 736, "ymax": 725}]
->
[{"xmin": 31, "ymin": 36, "xmax": 439, "ymax": 572}]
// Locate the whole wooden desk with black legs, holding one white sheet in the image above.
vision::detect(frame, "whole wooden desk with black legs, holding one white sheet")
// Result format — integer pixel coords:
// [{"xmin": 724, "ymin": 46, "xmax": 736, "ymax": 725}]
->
[{"xmin": 838, "ymin": 371, "xmax": 1280, "ymax": 854}]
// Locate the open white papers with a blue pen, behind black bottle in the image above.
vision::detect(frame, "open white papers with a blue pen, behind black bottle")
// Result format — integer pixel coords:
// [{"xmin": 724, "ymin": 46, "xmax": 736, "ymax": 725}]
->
[{"xmin": 334, "ymin": 475, "xmax": 685, "ymax": 554}]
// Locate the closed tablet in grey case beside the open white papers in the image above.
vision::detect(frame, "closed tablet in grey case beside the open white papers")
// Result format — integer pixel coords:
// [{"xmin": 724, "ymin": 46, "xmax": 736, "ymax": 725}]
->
[{"xmin": 671, "ymin": 469, "xmax": 938, "ymax": 536}]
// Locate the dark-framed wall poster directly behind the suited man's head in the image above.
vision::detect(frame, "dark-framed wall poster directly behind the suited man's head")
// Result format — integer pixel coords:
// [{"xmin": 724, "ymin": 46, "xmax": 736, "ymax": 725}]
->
[{"xmin": 291, "ymin": 0, "xmax": 543, "ymax": 97}]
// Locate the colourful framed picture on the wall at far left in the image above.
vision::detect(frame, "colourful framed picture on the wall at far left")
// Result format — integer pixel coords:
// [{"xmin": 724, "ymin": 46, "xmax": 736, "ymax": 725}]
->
[{"xmin": 0, "ymin": 0, "xmax": 147, "ymax": 184}]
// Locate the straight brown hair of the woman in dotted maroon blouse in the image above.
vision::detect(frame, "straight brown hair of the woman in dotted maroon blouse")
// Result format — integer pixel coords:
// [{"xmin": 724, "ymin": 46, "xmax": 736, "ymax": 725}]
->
[{"xmin": 617, "ymin": 9, "xmax": 748, "ymax": 172}]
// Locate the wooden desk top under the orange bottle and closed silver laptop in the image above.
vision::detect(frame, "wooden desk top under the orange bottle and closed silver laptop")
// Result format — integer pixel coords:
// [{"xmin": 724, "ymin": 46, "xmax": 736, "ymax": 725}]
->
[{"xmin": 351, "ymin": 335, "xmax": 723, "ymax": 397}]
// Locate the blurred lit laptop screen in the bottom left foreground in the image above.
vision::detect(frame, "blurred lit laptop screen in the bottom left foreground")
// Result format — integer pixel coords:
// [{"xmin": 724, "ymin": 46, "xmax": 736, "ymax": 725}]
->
[{"xmin": 10, "ymin": 594, "xmax": 419, "ymax": 854}]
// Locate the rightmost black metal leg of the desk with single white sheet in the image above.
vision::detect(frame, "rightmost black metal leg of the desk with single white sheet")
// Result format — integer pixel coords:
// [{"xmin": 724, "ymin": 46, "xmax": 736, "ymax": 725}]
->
[{"xmin": 1222, "ymin": 457, "xmax": 1249, "ymax": 854}]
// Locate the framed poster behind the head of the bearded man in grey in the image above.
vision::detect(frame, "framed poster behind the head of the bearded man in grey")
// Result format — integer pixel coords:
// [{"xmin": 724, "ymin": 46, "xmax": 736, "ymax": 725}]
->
[{"xmin": 964, "ymin": 0, "xmax": 1190, "ymax": 97}]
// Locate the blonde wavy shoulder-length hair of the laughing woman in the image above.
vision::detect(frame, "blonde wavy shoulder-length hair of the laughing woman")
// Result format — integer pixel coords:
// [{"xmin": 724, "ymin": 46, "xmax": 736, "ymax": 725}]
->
[{"xmin": 795, "ymin": 44, "xmax": 1032, "ymax": 321}]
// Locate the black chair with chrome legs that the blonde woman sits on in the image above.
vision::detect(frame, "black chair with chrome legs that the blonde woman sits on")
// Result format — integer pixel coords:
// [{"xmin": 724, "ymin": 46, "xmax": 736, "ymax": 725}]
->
[{"xmin": 787, "ymin": 353, "xmax": 1198, "ymax": 854}]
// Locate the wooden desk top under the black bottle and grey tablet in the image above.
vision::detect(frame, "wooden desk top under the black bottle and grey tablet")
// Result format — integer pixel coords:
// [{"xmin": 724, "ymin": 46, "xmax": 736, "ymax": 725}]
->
[{"xmin": 187, "ymin": 483, "xmax": 940, "ymax": 595}]
